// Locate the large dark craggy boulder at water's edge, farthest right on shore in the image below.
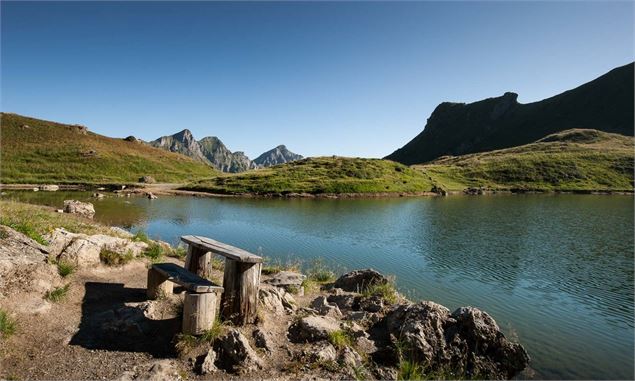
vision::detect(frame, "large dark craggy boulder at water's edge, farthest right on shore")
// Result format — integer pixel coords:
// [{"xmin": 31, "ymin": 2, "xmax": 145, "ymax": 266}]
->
[{"xmin": 374, "ymin": 301, "xmax": 529, "ymax": 379}]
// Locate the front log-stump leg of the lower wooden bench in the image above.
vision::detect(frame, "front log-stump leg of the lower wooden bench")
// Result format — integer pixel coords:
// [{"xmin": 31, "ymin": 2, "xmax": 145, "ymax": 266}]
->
[{"xmin": 183, "ymin": 291, "xmax": 217, "ymax": 335}]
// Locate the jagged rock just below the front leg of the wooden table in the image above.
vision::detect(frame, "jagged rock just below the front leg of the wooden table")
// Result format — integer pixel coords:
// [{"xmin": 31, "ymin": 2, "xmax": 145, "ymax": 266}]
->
[{"xmin": 214, "ymin": 328, "xmax": 263, "ymax": 372}]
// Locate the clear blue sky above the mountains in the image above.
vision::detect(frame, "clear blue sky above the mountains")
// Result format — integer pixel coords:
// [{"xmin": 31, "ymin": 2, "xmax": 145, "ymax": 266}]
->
[{"xmin": 1, "ymin": 1, "xmax": 634, "ymax": 158}]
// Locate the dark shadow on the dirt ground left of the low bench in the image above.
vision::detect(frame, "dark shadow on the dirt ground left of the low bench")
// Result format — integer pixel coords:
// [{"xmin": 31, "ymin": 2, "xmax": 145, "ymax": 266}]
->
[{"xmin": 69, "ymin": 282, "xmax": 181, "ymax": 358}]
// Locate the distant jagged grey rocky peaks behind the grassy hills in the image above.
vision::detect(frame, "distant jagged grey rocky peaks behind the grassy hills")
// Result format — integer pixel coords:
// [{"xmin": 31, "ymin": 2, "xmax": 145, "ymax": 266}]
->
[{"xmin": 149, "ymin": 129, "xmax": 302, "ymax": 173}]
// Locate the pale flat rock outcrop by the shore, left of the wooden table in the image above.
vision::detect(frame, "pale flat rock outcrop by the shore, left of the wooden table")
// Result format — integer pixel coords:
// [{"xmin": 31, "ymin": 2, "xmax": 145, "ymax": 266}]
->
[{"xmin": 46, "ymin": 228, "xmax": 148, "ymax": 267}]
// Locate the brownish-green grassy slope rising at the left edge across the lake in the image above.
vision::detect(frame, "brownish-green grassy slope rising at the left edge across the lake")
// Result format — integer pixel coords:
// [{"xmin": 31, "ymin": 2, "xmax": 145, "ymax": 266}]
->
[{"xmin": 0, "ymin": 113, "xmax": 216, "ymax": 184}]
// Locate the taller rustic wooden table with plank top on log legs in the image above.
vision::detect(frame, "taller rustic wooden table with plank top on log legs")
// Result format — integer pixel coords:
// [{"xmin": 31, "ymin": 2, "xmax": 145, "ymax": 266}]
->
[{"xmin": 181, "ymin": 235, "xmax": 262, "ymax": 325}]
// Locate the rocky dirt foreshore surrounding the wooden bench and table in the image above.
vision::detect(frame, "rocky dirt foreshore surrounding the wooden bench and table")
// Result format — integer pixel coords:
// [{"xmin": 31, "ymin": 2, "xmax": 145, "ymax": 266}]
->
[{"xmin": 0, "ymin": 205, "xmax": 529, "ymax": 380}]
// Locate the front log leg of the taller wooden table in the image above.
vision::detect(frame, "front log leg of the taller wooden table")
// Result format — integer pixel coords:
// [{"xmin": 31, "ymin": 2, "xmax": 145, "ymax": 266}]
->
[{"xmin": 221, "ymin": 258, "xmax": 262, "ymax": 325}]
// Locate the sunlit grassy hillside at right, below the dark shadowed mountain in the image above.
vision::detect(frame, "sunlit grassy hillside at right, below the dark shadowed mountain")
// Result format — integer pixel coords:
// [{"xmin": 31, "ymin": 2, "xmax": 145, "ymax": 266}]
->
[{"xmin": 413, "ymin": 129, "xmax": 635, "ymax": 191}]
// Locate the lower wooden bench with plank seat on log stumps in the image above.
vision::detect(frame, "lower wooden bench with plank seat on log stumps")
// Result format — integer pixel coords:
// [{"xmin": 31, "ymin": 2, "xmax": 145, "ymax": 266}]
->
[{"xmin": 147, "ymin": 263, "xmax": 223, "ymax": 335}]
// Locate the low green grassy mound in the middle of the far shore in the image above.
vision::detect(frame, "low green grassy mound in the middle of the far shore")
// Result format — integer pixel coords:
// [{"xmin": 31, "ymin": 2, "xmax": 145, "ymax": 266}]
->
[{"xmin": 184, "ymin": 157, "xmax": 432, "ymax": 194}]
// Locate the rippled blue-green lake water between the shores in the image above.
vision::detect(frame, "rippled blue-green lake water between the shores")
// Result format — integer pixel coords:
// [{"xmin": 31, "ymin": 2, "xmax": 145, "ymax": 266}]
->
[{"xmin": 2, "ymin": 192, "xmax": 635, "ymax": 379}]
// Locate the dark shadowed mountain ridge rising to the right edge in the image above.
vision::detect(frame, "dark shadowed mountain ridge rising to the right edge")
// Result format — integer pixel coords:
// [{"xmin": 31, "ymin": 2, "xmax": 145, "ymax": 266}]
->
[{"xmin": 386, "ymin": 63, "xmax": 634, "ymax": 165}]
